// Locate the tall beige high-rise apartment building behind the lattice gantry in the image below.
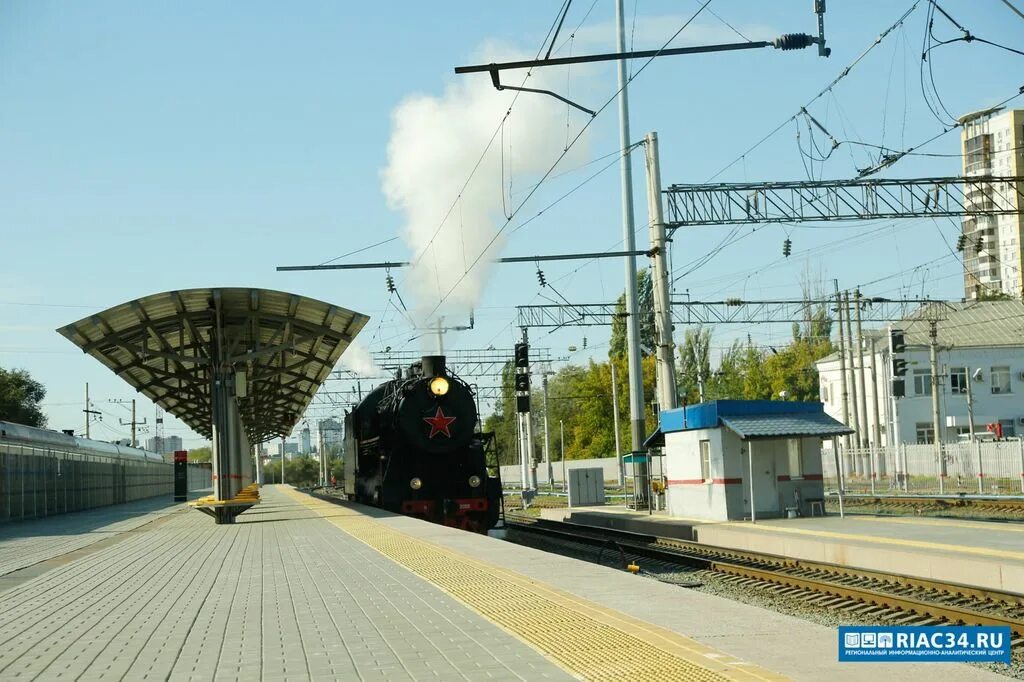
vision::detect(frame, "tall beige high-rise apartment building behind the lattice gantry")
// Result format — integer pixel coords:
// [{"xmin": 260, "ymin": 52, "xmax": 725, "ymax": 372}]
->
[{"xmin": 959, "ymin": 108, "xmax": 1024, "ymax": 299}]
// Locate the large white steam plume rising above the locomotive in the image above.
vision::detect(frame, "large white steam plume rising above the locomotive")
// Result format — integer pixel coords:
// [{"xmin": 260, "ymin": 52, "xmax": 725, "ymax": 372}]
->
[{"xmin": 381, "ymin": 47, "xmax": 592, "ymax": 324}]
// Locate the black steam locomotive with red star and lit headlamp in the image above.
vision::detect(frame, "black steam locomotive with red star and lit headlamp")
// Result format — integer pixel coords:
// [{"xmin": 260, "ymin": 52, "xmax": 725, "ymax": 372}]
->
[{"xmin": 344, "ymin": 355, "xmax": 501, "ymax": 532}]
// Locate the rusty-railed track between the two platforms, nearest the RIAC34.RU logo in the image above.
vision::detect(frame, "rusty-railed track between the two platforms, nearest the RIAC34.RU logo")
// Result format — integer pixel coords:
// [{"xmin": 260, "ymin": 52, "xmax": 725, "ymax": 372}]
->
[{"xmin": 506, "ymin": 514, "xmax": 1024, "ymax": 648}]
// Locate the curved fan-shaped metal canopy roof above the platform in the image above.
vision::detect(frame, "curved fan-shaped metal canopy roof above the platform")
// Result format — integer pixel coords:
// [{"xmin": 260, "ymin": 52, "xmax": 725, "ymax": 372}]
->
[{"xmin": 57, "ymin": 289, "xmax": 369, "ymax": 442}]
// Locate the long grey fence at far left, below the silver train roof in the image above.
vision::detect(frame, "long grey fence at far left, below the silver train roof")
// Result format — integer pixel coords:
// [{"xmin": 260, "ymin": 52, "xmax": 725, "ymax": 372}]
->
[{"xmin": 0, "ymin": 443, "xmax": 193, "ymax": 522}]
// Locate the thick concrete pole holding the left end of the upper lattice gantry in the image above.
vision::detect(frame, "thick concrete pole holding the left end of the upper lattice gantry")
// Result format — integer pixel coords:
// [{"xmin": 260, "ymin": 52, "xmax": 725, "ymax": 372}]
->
[{"xmin": 644, "ymin": 132, "xmax": 679, "ymax": 411}]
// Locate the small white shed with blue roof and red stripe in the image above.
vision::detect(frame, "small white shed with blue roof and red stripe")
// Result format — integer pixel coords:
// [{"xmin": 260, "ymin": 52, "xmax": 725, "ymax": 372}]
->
[{"xmin": 658, "ymin": 400, "xmax": 853, "ymax": 520}]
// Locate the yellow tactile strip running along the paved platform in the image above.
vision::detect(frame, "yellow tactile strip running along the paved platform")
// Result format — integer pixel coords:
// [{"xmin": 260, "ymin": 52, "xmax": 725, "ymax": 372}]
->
[{"xmin": 288, "ymin": 491, "xmax": 785, "ymax": 682}]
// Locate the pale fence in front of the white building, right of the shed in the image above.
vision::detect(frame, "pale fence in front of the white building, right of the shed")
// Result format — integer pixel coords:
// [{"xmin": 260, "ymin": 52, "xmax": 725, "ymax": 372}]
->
[{"xmin": 821, "ymin": 439, "xmax": 1024, "ymax": 495}]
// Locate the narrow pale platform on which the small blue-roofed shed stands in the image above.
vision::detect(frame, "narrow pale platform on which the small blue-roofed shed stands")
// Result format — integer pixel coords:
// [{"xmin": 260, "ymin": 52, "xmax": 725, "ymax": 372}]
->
[{"xmin": 544, "ymin": 507, "xmax": 1024, "ymax": 593}]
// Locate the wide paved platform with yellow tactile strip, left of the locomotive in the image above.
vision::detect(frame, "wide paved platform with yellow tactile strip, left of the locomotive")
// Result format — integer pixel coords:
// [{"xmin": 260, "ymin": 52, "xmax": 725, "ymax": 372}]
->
[{"xmin": 0, "ymin": 486, "xmax": 1000, "ymax": 680}]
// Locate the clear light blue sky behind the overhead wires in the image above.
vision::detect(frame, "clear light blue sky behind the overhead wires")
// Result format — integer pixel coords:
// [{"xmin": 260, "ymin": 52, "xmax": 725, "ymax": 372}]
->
[{"xmin": 0, "ymin": 0, "xmax": 1024, "ymax": 445}]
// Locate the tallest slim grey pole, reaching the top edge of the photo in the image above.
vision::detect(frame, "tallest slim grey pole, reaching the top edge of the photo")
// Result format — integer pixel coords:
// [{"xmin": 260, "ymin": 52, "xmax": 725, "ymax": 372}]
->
[{"xmin": 615, "ymin": 0, "xmax": 644, "ymax": 462}]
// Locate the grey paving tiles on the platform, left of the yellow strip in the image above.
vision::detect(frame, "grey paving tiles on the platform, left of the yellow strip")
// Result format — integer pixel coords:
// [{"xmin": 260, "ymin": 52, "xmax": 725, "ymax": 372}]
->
[{"xmin": 0, "ymin": 487, "xmax": 572, "ymax": 680}]
